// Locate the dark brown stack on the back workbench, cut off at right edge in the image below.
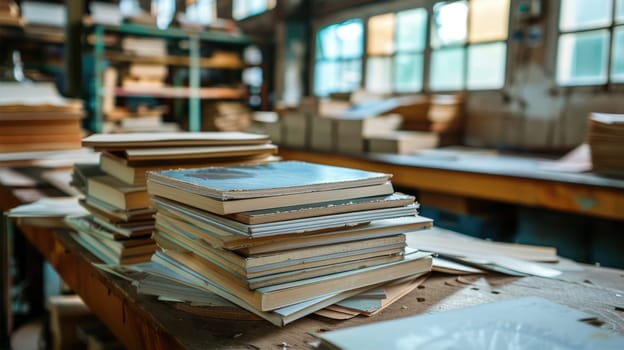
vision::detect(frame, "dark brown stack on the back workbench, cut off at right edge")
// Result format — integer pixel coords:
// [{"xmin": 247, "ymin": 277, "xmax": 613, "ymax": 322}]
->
[{"xmin": 587, "ymin": 113, "xmax": 624, "ymax": 177}]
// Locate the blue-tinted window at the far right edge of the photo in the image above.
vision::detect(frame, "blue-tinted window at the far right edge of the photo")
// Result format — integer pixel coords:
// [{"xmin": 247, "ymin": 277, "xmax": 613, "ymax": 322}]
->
[{"xmin": 557, "ymin": 0, "xmax": 624, "ymax": 86}]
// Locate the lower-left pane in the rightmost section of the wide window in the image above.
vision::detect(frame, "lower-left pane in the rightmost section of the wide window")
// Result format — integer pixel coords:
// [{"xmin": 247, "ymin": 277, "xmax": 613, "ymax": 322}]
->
[{"xmin": 430, "ymin": 47, "xmax": 464, "ymax": 91}]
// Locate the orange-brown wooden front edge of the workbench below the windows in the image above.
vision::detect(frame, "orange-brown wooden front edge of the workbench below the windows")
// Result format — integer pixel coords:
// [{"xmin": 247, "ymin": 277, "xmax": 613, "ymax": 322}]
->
[{"xmin": 280, "ymin": 149, "xmax": 624, "ymax": 220}]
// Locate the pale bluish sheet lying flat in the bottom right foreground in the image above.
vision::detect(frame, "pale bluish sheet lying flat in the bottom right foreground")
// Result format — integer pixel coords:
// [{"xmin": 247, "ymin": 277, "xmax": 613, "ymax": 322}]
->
[{"xmin": 315, "ymin": 297, "xmax": 624, "ymax": 350}]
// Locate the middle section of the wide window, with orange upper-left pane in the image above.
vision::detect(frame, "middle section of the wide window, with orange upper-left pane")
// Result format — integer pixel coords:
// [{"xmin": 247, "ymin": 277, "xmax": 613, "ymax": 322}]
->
[{"xmin": 366, "ymin": 8, "xmax": 427, "ymax": 93}]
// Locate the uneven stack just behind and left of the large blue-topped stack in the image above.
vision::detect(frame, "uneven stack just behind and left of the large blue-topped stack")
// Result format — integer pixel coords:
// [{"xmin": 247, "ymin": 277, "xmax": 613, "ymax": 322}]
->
[{"xmin": 66, "ymin": 133, "xmax": 277, "ymax": 264}]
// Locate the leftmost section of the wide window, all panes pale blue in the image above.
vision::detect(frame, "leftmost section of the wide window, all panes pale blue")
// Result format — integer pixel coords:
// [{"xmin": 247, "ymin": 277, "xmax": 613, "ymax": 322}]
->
[{"xmin": 314, "ymin": 19, "xmax": 364, "ymax": 96}]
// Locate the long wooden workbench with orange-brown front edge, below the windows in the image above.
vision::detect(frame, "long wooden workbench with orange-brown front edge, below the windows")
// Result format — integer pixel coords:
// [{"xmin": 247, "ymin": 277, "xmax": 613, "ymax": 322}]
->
[{"xmin": 280, "ymin": 149, "xmax": 624, "ymax": 220}]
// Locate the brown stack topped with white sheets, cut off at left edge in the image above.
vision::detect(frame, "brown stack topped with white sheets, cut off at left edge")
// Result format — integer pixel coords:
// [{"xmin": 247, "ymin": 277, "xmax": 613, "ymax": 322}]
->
[{"xmin": 0, "ymin": 82, "xmax": 84, "ymax": 152}]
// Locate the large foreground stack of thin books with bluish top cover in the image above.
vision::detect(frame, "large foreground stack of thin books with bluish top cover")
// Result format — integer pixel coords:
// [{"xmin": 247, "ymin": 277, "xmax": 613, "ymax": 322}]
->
[{"xmin": 147, "ymin": 161, "xmax": 432, "ymax": 325}]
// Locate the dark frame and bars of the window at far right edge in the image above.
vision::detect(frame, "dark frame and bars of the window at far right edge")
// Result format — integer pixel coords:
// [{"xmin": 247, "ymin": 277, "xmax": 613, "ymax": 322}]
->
[{"xmin": 553, "ymin": 0, "xmax": 624, "ymax": 89}]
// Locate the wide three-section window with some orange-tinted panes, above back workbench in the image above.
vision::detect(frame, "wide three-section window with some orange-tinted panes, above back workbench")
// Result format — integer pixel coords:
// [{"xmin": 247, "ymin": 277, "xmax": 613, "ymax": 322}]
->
[{"xmin": 314, "ymin": 0, "xmax": 510, "ymax": 96}]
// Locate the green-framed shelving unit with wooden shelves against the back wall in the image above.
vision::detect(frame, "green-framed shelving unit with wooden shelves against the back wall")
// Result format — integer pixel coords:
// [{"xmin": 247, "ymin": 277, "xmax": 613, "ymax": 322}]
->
[{"xmin": 90, "ymin": 24, "xmax": 251, "ymax": 132}]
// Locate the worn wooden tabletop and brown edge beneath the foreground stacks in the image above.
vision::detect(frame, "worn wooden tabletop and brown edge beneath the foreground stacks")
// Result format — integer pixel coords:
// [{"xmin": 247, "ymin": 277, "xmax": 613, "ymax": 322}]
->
[{"xmin": 13, "ymin": 221, "xmax": 624, "ymax": 349}]
